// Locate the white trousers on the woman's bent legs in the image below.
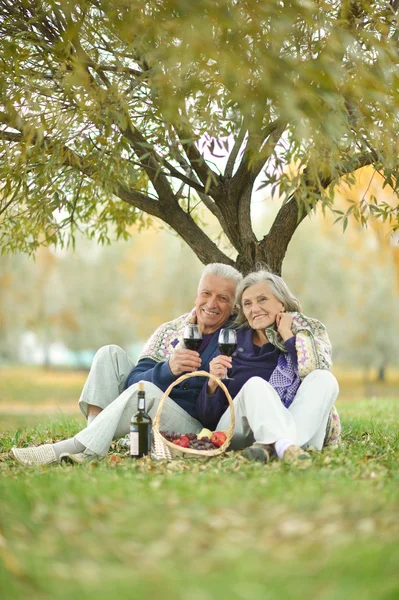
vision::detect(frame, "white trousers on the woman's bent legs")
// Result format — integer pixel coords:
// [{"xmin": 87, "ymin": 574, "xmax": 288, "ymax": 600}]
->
[{"xmin": 217, "ymin": 370, "xmax": 339, "ymax": 450}]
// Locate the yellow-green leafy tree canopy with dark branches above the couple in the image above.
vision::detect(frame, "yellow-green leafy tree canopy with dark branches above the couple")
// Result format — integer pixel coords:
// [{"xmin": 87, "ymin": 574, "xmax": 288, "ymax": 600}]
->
[{"xmin": 0, "ymin": 0, "xmax": 399, "ymax": 272}]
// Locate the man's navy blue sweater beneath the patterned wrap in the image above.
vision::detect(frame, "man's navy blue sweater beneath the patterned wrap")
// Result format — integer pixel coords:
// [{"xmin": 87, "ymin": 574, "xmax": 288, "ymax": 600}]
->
[{"xmin": 126, "ymin": 331, "xmax": 219, "ymax": 420}]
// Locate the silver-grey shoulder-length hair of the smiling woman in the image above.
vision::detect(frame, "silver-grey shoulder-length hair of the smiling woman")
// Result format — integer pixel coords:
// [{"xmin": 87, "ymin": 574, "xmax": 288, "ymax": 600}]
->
[{"xmin": 234, "ymin": 269, "xmax": 301, "ymax": 327}]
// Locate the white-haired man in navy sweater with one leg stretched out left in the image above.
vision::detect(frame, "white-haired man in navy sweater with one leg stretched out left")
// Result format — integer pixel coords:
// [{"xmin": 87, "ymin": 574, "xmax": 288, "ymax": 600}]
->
[{"xmin": 11, "ymin": 263, "xmax": 242, "ymax": 465}]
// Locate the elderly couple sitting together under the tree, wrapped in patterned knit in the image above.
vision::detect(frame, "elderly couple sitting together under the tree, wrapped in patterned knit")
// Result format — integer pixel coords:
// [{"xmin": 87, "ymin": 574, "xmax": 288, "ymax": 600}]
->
[{"xmin": 11, "ymin": 263, "xmax": 340, "ymax": 465}]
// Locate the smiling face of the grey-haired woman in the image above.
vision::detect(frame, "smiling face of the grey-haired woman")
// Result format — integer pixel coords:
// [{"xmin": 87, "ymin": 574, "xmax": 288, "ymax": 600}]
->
[{"xmin": 242, "ymin": 281, "xmax": 284, "ymax": 329}]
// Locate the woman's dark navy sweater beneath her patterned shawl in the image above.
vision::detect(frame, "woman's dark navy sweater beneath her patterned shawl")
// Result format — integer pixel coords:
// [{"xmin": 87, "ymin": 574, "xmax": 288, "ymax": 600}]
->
[{"xmin": 197, "ymin": 329, "xmax": 297, "ymax": 431}]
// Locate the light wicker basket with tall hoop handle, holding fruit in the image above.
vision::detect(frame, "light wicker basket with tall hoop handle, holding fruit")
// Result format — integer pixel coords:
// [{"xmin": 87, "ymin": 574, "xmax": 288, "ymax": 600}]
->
[{"xmin": 152, "ymin": 371, "xmax": 235, "ymax": 460}]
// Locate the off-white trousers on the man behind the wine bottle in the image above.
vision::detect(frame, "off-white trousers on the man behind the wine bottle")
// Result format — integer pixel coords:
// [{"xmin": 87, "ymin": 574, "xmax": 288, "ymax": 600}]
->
[{"xmin": 75, "ymin": 345, "xmax": 202, "ymax": 456}]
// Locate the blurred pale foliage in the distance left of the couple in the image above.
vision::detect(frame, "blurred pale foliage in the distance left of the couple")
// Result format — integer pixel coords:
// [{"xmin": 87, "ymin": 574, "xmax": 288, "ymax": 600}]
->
[{"xmin": 0, "ymin": 228, "xmax": 203, "ymax": 364}]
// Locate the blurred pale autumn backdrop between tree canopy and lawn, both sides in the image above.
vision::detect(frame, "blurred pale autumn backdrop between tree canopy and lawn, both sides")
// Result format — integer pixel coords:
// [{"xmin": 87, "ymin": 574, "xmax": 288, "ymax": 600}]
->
[{"xmin": 0, "ymin": 168, "xmax": 399, "ymax": 396}]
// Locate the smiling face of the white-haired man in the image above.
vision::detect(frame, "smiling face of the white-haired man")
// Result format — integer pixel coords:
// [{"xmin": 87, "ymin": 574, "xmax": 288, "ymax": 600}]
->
[{"xmin": 195, "ymin": 275, "xmax": 236, "ymax": 333}]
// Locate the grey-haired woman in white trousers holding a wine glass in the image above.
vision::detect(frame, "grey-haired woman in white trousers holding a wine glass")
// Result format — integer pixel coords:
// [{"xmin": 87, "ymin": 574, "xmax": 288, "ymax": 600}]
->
[{"xmin": 197, "ymin": 271, "xmax": 340, "ymax": 462}]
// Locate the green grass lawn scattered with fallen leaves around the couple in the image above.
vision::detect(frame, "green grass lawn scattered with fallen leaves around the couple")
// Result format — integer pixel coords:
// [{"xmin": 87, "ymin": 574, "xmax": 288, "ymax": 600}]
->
[{"xmin": 0, "ymin": 368, "xmax": 399, "ymax": 600}]
